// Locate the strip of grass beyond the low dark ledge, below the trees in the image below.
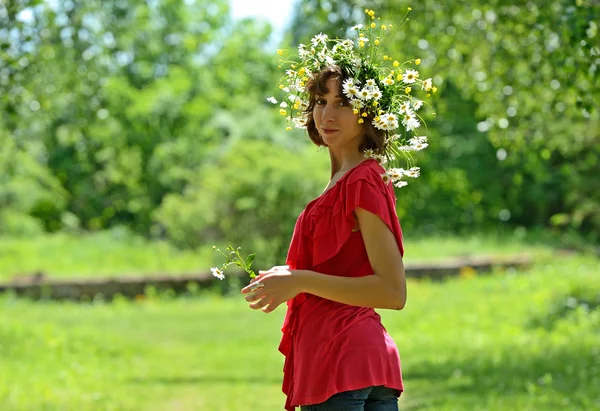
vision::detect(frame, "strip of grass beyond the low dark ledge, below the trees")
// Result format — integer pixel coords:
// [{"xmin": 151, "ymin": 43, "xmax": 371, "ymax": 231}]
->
[{"xmin": 0, "ymin": 231, "xmax": 551, "ymax": 281}]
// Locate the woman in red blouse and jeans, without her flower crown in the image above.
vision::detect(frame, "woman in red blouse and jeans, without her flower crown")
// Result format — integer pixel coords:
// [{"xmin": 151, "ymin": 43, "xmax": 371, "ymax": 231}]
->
[{"xmin": 242, "ymin": 66, "xmax": 406, "ymax": 411}]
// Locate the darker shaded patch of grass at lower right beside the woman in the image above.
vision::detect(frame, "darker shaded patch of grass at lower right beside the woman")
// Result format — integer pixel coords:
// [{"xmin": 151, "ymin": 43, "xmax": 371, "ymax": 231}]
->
[{"xmin": 403, "ymin": 346, "xmax": 600, "ymax": 410}]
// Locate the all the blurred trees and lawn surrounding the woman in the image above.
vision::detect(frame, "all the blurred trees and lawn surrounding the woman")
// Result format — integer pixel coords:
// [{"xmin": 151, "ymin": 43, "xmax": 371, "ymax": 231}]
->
[{"xmin": 0, "ymin": 0, "xmax": 600, "ymax": 410}]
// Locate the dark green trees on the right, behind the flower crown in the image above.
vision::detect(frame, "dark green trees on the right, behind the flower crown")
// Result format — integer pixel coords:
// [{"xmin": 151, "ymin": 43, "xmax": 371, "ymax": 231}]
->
[{"xmin": 290, "ymin": 0, "xmax": 600, "ymax": 239}]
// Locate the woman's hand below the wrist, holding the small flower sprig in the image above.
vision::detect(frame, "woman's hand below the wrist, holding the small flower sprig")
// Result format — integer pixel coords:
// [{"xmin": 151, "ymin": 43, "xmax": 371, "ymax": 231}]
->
[{"xmin": 242, "ymin": 265, "xmax": 300, "ymax": 313}]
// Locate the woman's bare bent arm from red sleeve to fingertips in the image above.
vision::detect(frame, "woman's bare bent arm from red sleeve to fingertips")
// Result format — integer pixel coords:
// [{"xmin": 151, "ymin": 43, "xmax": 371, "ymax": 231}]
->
[{"xmin": 242, "ymin": 208, "xmax": 406, "ymax": 312}]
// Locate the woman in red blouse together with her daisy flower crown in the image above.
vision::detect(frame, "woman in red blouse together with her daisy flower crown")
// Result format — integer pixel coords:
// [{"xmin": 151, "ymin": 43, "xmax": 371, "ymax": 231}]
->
[{"xmin": 242, "ymin": 10, "xmax": 431, "ymax": 411}]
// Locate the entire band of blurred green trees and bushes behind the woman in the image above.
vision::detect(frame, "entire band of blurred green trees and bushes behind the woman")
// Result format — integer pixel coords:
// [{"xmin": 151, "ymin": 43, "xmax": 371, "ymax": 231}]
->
[{"xmin": 0, "ymin": 0, "xmax": 600, "ymax": 251}]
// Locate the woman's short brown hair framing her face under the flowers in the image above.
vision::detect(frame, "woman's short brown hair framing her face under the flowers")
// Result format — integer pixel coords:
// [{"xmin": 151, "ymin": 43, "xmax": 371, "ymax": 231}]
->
[{"xmin": 304, "ymin": 65, "xmax": 387, "ymax": 154}]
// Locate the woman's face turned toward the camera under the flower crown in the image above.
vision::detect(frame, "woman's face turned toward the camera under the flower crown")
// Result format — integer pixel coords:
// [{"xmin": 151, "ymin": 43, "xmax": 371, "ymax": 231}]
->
[{"xmin": 312, "ymin": 77, "xmax": 363, "ymax": 150}]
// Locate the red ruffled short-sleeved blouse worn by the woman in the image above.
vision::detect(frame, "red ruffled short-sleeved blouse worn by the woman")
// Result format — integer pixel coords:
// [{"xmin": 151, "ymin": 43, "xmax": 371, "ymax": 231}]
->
[{"xmin": 279, "ymin": 159, "xmax": 404, "ymax": 411}]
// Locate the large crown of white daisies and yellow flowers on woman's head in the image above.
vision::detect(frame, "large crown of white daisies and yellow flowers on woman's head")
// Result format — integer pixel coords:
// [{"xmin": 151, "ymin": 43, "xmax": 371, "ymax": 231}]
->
[{"xmin": 267, "ymin": 7, "xmax": 437, "ymax": 187}]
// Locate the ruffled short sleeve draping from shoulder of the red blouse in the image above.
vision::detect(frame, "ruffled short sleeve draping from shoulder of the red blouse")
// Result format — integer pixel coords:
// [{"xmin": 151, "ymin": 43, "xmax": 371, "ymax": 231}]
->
[{"xmin": 311, "ymin": 161, "xmax": 404, "ymax": 267}]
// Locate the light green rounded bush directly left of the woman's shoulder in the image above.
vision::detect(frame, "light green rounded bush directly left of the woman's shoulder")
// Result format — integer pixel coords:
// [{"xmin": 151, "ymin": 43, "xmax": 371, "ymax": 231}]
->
[{"xmin": 156, "ymin": 140, "xmax": 328, "ymax": 267}]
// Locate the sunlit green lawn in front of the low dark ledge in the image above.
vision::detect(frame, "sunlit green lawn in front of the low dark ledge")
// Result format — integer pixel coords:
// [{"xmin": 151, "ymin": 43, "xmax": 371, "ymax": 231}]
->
[{"xmin": 0, "ymin": 257, "xmax": 600, "ymax": 411}]
